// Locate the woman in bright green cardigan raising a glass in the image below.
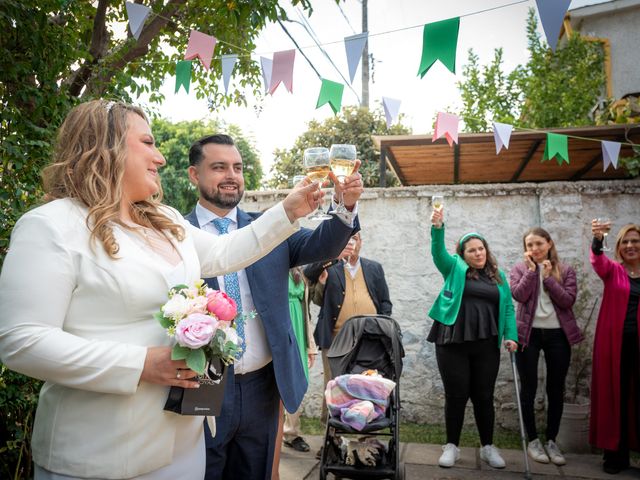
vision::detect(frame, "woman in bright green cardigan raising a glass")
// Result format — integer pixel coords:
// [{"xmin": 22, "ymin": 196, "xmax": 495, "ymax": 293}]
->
[{"xmin": 427, "ymin": 208, "xmax": 518, "ymax": 468}]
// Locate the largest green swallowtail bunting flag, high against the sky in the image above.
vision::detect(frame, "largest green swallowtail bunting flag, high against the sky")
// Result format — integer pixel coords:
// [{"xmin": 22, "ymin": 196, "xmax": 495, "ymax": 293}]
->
[{"xmin": 418, "ymin": 17, "xmax": 460, "ymax": 78}]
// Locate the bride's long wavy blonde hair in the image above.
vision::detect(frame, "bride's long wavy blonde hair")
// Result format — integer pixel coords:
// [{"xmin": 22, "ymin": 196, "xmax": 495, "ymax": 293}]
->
[{"xmin": 42, "ymin": 100, "xmax": 184, "ymax": 258}]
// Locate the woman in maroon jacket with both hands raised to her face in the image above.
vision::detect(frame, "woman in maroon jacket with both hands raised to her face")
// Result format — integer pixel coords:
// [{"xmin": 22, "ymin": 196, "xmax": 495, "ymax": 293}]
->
[{"xmin": 509, "ymin": 227, "xmax": 583, "ymax": 465}]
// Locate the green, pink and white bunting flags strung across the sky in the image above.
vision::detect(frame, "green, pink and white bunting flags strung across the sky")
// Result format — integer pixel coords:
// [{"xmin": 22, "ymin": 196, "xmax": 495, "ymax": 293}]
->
[{"xmin": 126, "ymin": 0, "xmax": 622, "ymax": 171}]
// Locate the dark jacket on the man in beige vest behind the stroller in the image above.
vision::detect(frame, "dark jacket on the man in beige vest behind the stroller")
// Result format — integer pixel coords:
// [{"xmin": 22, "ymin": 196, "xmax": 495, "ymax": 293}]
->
[{"xmin": 304, "ymin": 257, "xmax": 392, "ymax": 349}]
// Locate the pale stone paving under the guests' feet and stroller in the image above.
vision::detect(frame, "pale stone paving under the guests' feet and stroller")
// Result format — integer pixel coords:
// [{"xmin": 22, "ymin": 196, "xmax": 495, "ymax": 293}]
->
[{"xmin": 280, "ymin": 436, "xmax": 640, "ymax": 480}]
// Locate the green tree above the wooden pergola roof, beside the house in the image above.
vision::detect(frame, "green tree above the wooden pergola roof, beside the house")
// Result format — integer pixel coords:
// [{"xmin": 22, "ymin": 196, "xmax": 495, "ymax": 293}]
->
[{"xmin": 458, "ymin": 10, "xmax": 605, "ymax": 132}]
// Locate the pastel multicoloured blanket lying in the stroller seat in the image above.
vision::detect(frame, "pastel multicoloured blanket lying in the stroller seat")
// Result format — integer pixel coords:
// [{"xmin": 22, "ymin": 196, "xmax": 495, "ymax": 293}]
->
[{"xmin": 324, "ymin": 374, "xmax": 396, "ymax": 430}]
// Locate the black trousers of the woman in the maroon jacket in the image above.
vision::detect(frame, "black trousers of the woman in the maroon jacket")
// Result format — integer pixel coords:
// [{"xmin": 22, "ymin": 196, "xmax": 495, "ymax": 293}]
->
[{"xmin": 516, "ymin": 328, "xmax": 571, "ymax": 441}]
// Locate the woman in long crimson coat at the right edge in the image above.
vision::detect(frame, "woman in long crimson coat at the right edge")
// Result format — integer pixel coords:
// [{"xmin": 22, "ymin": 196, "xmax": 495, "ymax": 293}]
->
[{"xmin": 589, "ymin": 220, "xmax": 640, "ymax": 474}]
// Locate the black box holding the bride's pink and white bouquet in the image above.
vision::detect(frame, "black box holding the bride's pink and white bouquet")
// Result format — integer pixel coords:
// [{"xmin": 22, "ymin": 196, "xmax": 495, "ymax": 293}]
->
[{"xmin": 164, "ymin": 358, "xmax": 227, "ymax": 416}]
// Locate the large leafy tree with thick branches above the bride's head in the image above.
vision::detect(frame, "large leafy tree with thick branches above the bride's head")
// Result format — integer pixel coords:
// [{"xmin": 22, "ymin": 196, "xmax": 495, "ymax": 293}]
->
[{"xmin": 0, "ymin": 0, "xmax": 311, "ymax": 260}]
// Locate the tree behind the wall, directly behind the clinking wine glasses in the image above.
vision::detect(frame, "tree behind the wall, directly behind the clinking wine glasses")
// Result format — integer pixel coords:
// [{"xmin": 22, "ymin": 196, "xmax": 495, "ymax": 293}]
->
[{"xmin": 267, "ymin": 106, "xmax": 411, "ymax": 188}]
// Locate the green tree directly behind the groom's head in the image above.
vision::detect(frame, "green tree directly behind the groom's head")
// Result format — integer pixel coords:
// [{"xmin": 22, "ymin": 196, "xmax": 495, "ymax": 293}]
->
[{"xmin": 151, "ymin": 119, "xmax": 262, "ymax": 214}]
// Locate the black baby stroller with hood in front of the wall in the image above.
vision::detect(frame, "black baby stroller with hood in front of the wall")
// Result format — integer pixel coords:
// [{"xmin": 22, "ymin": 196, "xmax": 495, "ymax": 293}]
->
[{"xmin": 320, "ymin": 315, "xmax": 404, "ymax": 480}]
